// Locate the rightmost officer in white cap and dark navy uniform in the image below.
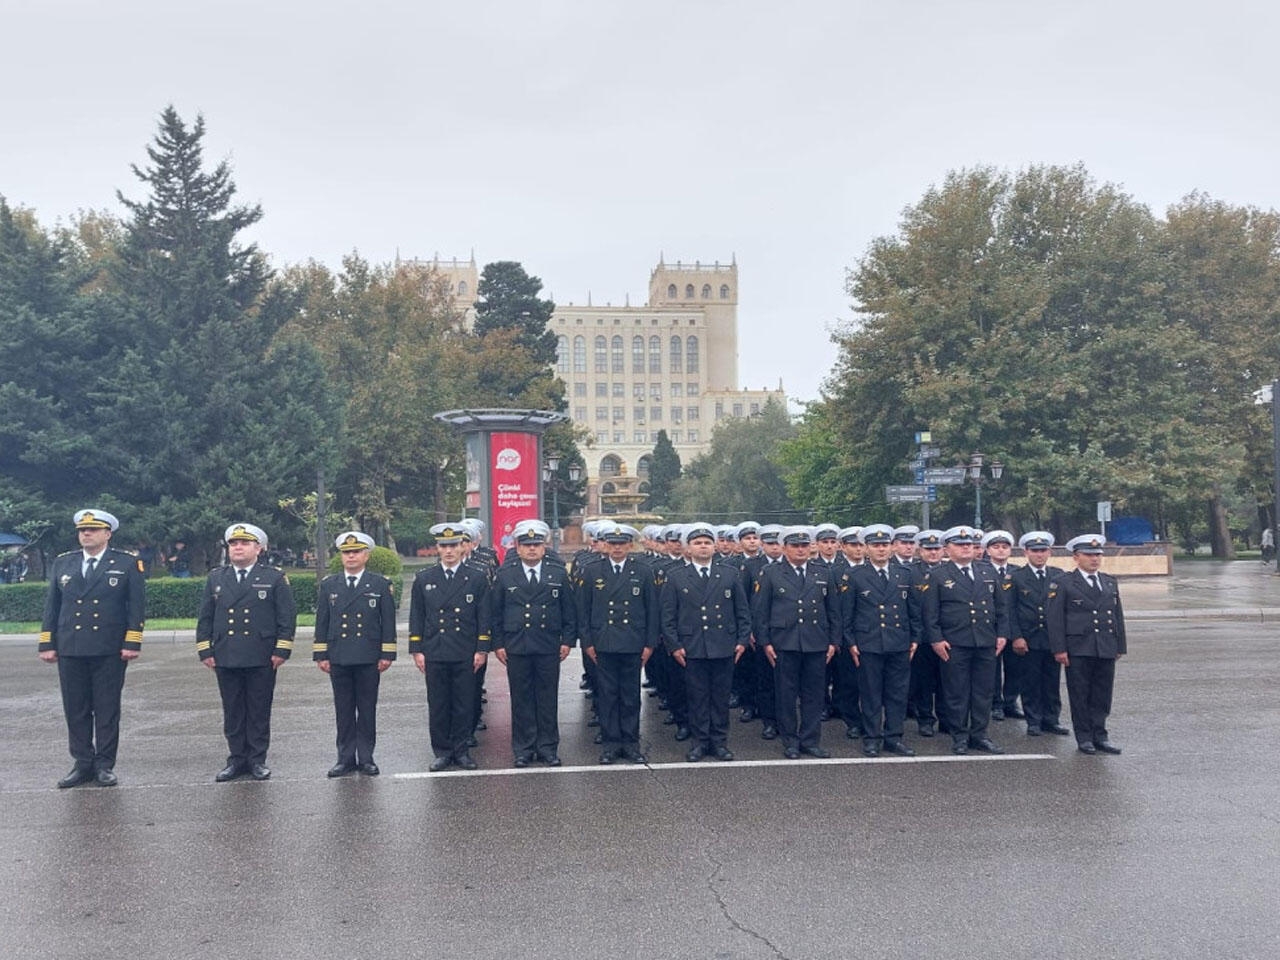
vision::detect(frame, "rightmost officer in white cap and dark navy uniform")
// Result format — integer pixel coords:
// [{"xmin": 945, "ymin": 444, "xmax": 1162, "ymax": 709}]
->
[{"xmin": 1044, "ymin": 534, "xmax": 1128, "ymax": 754}]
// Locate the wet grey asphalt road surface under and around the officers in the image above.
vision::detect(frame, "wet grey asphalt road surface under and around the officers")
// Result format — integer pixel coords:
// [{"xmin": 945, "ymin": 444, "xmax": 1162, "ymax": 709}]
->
[{"xmin": 0, "ymin": 564, "xmax": 1280, "ymax": 960}]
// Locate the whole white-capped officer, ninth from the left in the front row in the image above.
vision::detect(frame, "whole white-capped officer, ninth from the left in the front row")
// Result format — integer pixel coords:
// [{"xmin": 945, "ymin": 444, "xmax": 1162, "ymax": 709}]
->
[{"xmin": 844, "ymin": 524, "xmax": 920, "ymax": 756}]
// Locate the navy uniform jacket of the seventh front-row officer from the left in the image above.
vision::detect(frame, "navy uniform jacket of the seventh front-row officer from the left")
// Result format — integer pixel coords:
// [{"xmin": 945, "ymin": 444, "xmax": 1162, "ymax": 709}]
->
[{"xmin": 660, "ymin": 562, "xmax": 751, "ymax": 659}]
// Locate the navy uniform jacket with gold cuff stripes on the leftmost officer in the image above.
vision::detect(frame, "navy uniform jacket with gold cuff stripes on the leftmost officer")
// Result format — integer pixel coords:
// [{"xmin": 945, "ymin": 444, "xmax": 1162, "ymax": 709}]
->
[{"xmin": 40, "ymin": 547, "xmax": 146, "ymax": 657}]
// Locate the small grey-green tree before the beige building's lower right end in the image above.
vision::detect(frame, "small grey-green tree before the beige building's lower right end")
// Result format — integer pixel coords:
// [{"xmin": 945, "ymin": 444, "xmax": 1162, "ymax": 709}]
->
[{"xmin": 670, "ymin": 399, "xmax": 805, "ymax": 524}]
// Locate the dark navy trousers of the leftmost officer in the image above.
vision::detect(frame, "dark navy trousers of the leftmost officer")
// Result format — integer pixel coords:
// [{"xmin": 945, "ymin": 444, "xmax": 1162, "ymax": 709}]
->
[{"xmin": 58, "ymin": 653, "xmax": 128, "ymax": 769}]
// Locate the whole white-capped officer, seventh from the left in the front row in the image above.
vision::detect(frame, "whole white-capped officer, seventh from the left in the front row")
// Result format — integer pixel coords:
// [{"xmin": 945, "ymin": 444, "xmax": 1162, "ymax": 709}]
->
[{"xmin": 662, "ymin": 524, "xmax": 751, "ymax": 763}]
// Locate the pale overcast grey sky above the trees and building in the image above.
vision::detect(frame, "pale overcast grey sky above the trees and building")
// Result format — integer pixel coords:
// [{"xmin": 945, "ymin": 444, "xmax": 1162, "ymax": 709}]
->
[{"xmin": 0, "ymin": 0, "xmax": 1280, "ymax": 399}]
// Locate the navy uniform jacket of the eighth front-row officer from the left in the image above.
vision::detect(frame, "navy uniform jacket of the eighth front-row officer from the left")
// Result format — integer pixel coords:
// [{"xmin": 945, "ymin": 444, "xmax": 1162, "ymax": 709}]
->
[{"xmin": 751, "ymin": 558, "xmax": 844, "ymax": 653}]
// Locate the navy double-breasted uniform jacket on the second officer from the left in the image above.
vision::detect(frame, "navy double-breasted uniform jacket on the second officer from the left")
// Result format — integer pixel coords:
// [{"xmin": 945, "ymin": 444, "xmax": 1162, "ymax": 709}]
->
[{"xmin": 196, "ymin": 563, "xmax": 298, "ymax": 667}]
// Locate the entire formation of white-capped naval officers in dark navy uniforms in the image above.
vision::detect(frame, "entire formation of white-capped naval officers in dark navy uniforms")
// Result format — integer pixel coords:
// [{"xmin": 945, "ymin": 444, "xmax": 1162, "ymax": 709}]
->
[{"xmin": 40, "ymin": 509, "xmax": 1125, "ymax": 787}]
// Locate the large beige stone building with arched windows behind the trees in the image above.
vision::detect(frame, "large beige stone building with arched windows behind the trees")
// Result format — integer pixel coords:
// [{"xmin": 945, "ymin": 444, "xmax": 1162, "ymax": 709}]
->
[{"xmin": 404, "ymin": 256, "xmax": 786, "ymax": 513}]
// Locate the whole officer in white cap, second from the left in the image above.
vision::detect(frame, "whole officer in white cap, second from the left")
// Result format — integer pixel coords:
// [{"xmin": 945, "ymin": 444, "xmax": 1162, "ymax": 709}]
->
[{"xmin": 196, "ymin": 524, "xmax": 298, "ymax": 783}]
